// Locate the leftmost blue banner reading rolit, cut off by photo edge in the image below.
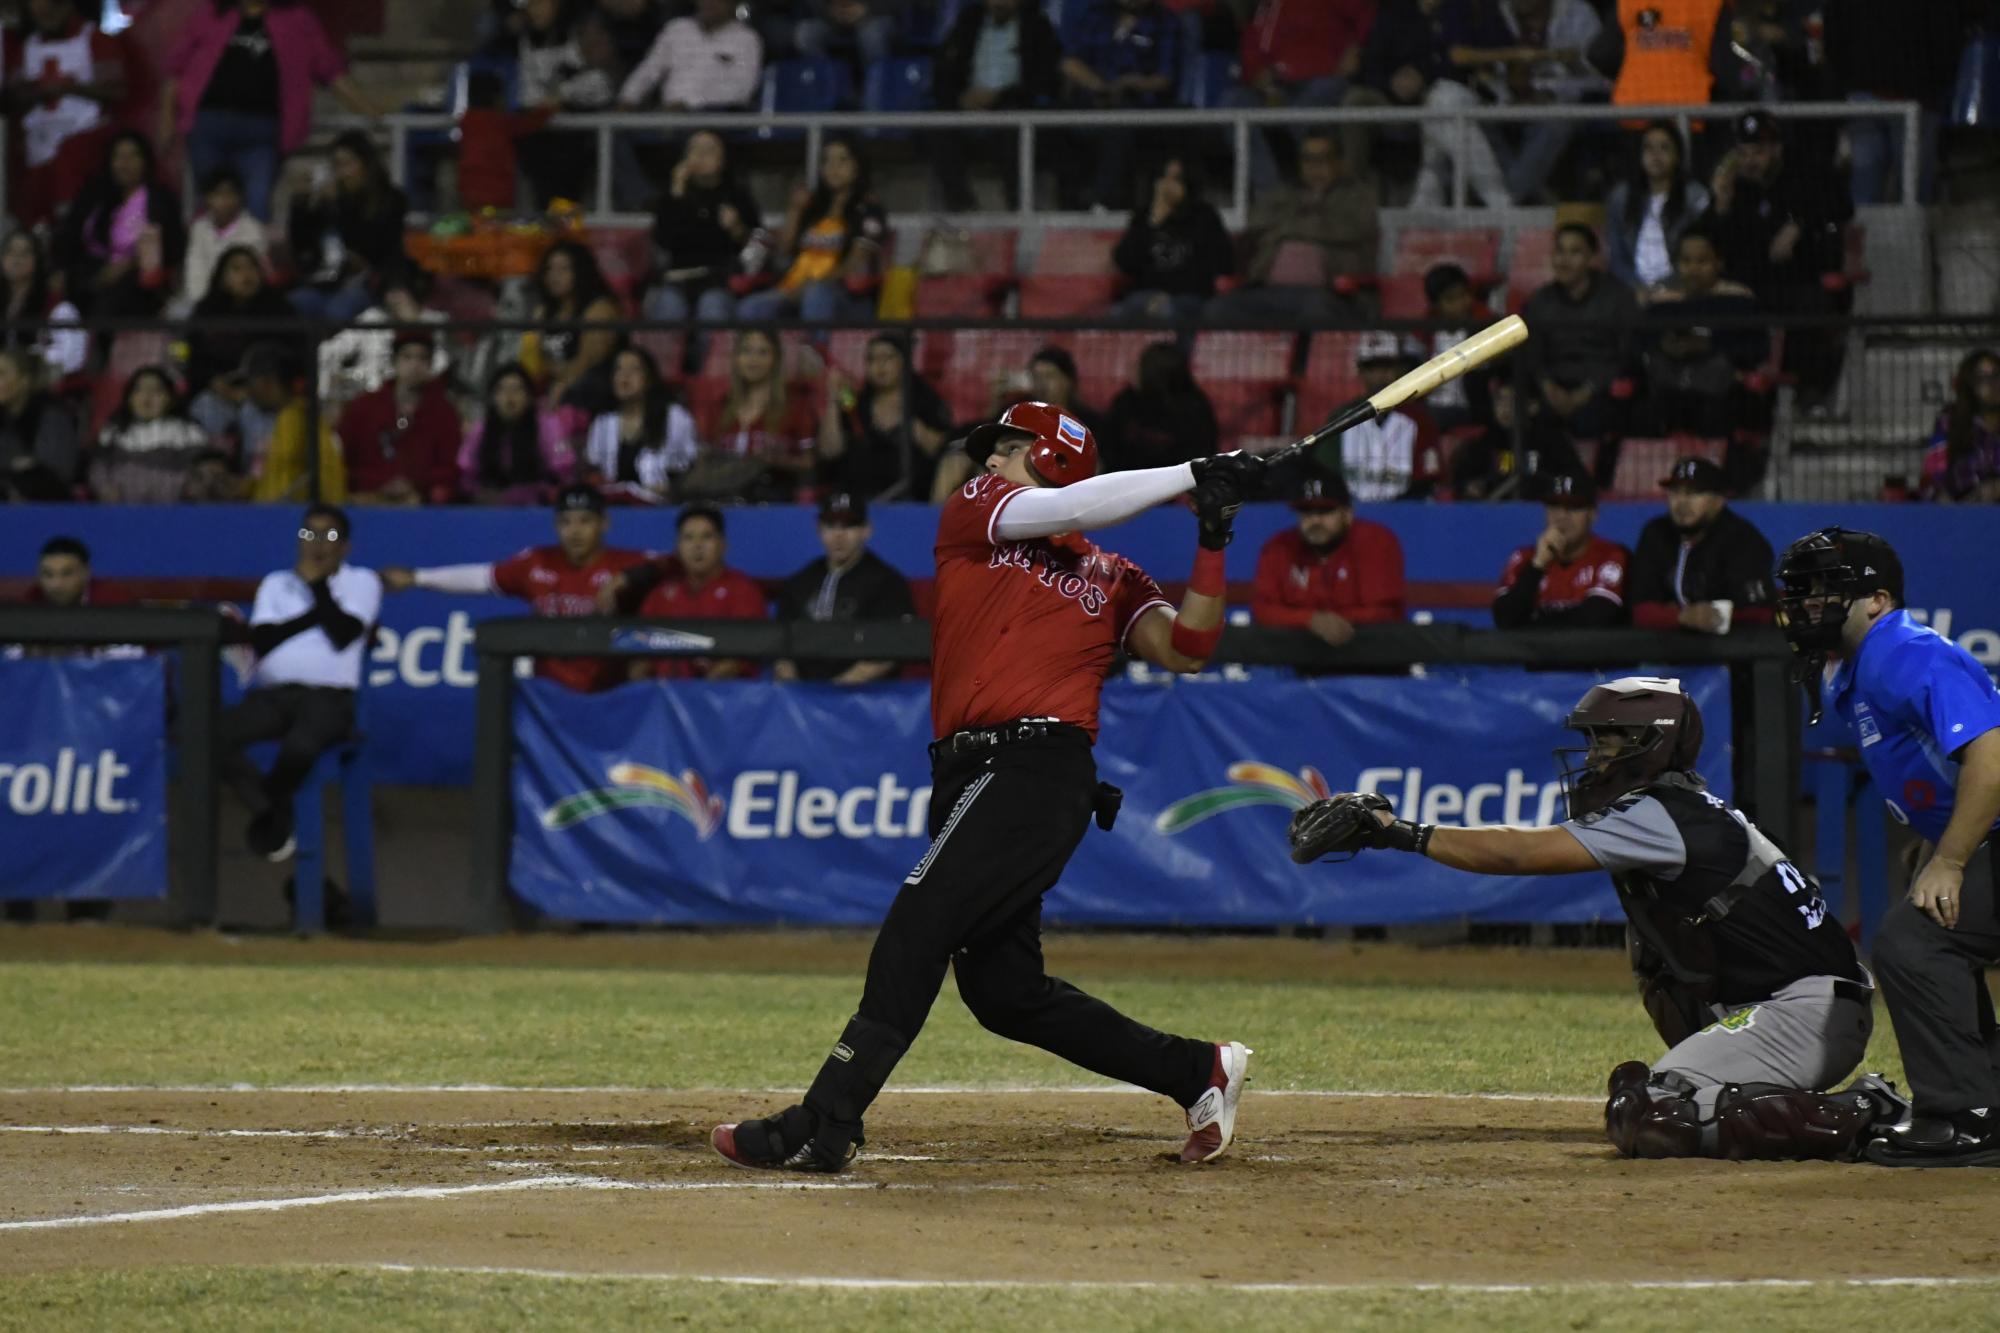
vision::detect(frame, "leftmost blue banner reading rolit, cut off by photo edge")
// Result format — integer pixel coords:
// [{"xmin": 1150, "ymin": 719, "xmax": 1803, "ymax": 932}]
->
[{"xmin": 0, "ymin": 656, "xmax": 166, "ymax": 899}]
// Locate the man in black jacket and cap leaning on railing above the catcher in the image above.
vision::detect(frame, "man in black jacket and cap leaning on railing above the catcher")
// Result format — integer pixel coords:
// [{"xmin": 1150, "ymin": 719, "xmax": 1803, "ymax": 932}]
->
[{"xmin": 1628, "ymin": 458, "xmax": 1772, "ymax": 634}]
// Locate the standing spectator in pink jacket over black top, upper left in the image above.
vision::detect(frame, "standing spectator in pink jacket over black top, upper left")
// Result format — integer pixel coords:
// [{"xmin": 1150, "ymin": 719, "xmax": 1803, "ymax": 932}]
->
[{"xmin": 160, "ymin": 0, "xmax": 380, "ymax": 222}]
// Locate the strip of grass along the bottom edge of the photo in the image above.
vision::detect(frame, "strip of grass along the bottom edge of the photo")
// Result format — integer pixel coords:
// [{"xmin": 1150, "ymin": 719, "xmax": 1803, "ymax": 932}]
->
[{"xmin": 0, "ymin": 1269, "xmax": 2000, "ymax": 1333}]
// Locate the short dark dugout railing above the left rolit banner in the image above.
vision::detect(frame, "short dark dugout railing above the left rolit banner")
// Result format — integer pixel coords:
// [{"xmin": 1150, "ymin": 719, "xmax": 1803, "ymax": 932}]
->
[{"xmin": 0, "ymin": 604, "xmax": 228, "ymax": 927}]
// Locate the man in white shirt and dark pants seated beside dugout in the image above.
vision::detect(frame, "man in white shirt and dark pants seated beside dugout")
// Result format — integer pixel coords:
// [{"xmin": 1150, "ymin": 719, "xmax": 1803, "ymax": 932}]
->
[{"xmin": 220, "ymin": 504, "xmax": 382, "ymax": 861}]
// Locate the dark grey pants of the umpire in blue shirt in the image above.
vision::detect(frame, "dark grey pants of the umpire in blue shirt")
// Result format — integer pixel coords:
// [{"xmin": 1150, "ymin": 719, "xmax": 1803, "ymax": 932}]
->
[{"xmin": 1874, "ymin": 839, "xmax": 2000, "ymax": 1115}]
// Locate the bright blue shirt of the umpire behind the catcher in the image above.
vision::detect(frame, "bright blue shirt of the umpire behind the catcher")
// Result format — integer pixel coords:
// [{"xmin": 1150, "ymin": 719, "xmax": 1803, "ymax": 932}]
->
[{"xmin": 1826, "ymin": 610, "xmax": 2000, "ymax": 843}]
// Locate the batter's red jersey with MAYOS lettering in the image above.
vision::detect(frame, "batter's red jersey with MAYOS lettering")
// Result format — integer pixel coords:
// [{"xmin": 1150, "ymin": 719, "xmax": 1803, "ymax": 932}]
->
[{"xmin": 930, "ymin": 476, "xmax": 1170, "ymax": 737}]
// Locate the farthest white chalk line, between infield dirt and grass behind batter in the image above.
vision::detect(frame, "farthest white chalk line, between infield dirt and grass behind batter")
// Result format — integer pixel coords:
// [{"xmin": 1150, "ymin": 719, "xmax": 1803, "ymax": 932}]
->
[{"xmin": 0, "ymin": 1083, "xmax": 1604, "ymax": 1105}]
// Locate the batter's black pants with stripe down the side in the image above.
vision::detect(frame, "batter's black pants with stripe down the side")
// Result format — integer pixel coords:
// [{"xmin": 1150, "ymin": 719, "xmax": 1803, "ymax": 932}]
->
[{"xmin": 806, "ymin": 727, "xmax": 1214, "ymax": 1135}]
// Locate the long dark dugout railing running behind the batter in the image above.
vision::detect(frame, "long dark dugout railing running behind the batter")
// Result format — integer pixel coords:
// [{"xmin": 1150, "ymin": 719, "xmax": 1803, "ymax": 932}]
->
[{"xmin": 472, "ymin": 616, "xmax": 1800, "ymax": 931}]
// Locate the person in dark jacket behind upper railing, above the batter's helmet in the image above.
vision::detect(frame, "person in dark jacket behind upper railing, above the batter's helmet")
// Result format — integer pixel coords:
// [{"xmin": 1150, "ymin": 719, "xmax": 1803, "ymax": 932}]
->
[{"xmin": 930, "ymin": 0, "xmax": 1062, "ymax": 212}]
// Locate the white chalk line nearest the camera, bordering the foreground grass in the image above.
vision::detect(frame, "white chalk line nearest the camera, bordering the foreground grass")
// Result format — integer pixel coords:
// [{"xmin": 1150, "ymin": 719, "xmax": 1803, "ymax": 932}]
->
[{"xmin": 352, "ymin": 1263, "xmax": 2000, "ymax": 1295}]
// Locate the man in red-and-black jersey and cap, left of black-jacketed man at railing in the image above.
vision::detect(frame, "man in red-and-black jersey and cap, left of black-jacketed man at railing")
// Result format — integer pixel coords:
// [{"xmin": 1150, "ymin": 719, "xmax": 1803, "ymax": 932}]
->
[{"xmin": 1494, "ymin": 472, "xmax": 1632, "ymax": 628}]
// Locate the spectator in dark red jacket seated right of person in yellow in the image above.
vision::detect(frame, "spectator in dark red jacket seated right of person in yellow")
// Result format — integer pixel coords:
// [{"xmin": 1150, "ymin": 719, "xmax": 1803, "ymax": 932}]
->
[{"xmin": 334, "ymin": 330, "xmax": 462, "ymax": 504}]
